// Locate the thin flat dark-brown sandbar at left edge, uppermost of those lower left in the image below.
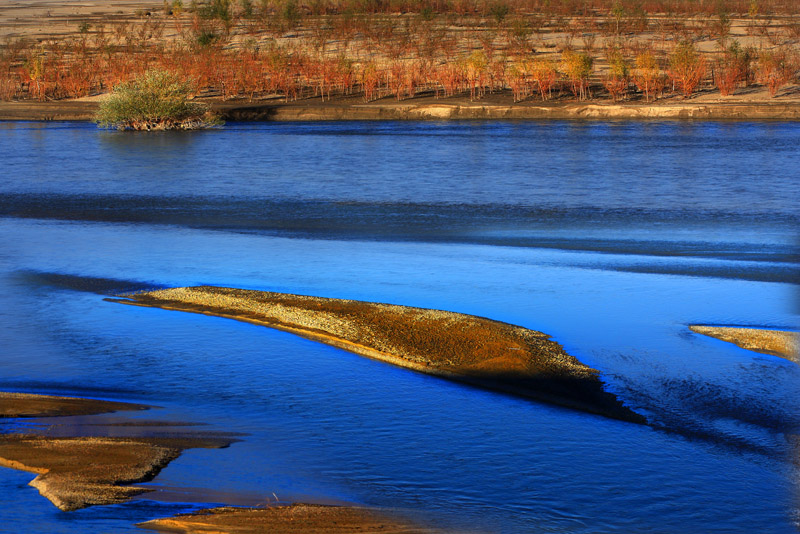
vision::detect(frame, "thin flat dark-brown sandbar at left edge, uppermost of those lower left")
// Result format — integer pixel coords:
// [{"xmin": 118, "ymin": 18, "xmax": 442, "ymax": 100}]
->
[{"xmin": 0, "ymin": 391, "xmax": 149, "ymax": 417}]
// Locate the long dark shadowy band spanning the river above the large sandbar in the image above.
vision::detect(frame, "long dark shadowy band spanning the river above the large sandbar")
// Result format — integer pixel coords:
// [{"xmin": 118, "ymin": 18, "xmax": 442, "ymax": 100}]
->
[{"xmin": 0, "ymin": 194, "xmax": 800, "ymax": 283}]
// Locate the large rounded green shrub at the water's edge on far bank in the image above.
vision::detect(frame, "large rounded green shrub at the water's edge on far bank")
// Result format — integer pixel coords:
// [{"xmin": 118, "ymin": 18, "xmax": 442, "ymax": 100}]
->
[{"xmin": 94, "ymin": 70, "xmax": 221, "ymax": 130}]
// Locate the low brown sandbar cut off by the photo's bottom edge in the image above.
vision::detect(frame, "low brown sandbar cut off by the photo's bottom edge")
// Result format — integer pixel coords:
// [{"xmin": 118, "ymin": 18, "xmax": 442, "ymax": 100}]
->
[{"xmin": 139, "ymin": 504, "xmax": 456, "ymax": 534}]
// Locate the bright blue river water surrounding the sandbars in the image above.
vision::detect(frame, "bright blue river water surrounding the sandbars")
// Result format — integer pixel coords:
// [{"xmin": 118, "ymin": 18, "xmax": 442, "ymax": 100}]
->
[{"xmin": 0, "ymin": 122, "xmax": 800, "ymax": 534}]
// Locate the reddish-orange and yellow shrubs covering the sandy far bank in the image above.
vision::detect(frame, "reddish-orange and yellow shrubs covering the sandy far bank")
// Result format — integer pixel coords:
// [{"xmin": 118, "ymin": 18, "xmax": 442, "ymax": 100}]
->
[{"xmin": 0, "ymin": 0, "xmax": 800, "ymax": 105}]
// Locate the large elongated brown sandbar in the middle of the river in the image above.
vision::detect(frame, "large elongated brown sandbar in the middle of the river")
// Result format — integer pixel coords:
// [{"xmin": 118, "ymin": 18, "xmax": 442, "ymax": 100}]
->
[{"xmin": 111, "ymin": 286, "xmax": 645, "ymax": 423}]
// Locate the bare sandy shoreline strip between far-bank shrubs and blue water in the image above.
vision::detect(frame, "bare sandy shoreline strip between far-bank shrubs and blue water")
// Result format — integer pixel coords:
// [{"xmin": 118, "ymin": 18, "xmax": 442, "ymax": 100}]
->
[{"xmin": 0, "ymin": 95, "xmax": 800, "ymax": 122}]
